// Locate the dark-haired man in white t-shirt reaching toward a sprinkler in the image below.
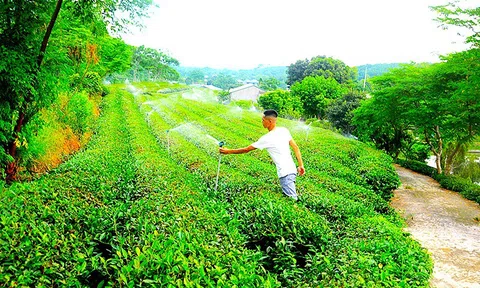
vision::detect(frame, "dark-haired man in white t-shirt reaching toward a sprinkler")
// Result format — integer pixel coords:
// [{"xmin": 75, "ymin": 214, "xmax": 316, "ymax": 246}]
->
[{"xmin": 220, "ymin": 110, "xmax": 305, "ymax": 200}]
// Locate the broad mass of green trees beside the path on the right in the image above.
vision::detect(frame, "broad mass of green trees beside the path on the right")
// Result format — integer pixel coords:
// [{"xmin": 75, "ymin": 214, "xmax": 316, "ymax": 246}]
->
[{"xmin": 354, "ymin": 49, "xmax": 480, "ymax": 173}]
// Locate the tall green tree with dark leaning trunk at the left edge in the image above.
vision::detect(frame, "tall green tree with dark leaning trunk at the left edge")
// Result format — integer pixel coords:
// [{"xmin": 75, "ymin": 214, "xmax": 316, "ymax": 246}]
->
[{"xmin": 0, "ymin": 0, "xmax": 151, "ymax": 181}]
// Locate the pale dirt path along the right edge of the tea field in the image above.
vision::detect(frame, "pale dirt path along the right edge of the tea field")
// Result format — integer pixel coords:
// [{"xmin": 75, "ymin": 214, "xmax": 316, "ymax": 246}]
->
[{"xmin": 392, "ymin": 166, "xmax": 480, "ymax": 288}]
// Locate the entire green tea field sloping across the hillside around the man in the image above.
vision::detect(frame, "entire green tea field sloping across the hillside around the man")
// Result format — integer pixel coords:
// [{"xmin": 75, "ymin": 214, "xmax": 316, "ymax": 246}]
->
[{"xmin": 0, "ymin": 83, "xmax": 432, "ymax": 287}]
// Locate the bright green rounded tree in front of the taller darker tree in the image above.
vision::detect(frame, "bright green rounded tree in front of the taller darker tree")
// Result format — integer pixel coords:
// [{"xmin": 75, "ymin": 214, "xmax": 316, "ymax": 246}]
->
[{"xmin": 291, "ymin": 76, "xmax": 344, "ymax": 119}]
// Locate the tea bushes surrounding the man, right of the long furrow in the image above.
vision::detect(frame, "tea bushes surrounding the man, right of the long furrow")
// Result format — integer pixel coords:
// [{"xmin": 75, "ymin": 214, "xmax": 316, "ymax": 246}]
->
[{"xmin": 128, "ymin": 82, "xmax": 431, "ymax": 287}]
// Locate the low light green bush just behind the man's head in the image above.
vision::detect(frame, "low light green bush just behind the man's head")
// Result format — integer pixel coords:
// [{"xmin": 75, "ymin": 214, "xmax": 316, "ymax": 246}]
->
[{"xmin": 258, "ymin": 90, "xmax": 303, "ymax": 119}]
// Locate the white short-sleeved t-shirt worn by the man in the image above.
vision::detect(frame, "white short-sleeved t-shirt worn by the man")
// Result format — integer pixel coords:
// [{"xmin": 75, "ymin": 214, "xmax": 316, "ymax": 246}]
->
[{"xmin": 252, "ymin": 127, "xmax": 297, "ymax": 178}]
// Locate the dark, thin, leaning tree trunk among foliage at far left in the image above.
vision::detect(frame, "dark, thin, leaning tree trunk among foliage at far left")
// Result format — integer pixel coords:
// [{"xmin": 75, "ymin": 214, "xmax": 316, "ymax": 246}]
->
[{"xmin": 5, "ymin": 0, "xmax": 63, "ymax": 182}]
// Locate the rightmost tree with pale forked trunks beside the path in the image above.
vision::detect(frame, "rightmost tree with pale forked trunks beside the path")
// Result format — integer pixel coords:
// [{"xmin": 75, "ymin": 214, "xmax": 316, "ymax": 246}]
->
[{"xmin": 411, "ymin": 49, "xmax": 480, "ymax": 174}]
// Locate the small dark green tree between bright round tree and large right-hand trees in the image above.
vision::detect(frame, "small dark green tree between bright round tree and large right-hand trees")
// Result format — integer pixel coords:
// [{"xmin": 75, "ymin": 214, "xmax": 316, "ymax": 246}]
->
[{"xmin": 327, "ymin": 90, "xmax": 365, "ymax": 134}]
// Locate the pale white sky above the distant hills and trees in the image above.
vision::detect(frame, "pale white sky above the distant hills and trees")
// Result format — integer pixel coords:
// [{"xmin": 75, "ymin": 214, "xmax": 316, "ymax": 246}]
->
[{"xmin": 122, "ymin": 0, "xmax": 472, "ymax": 69}]
